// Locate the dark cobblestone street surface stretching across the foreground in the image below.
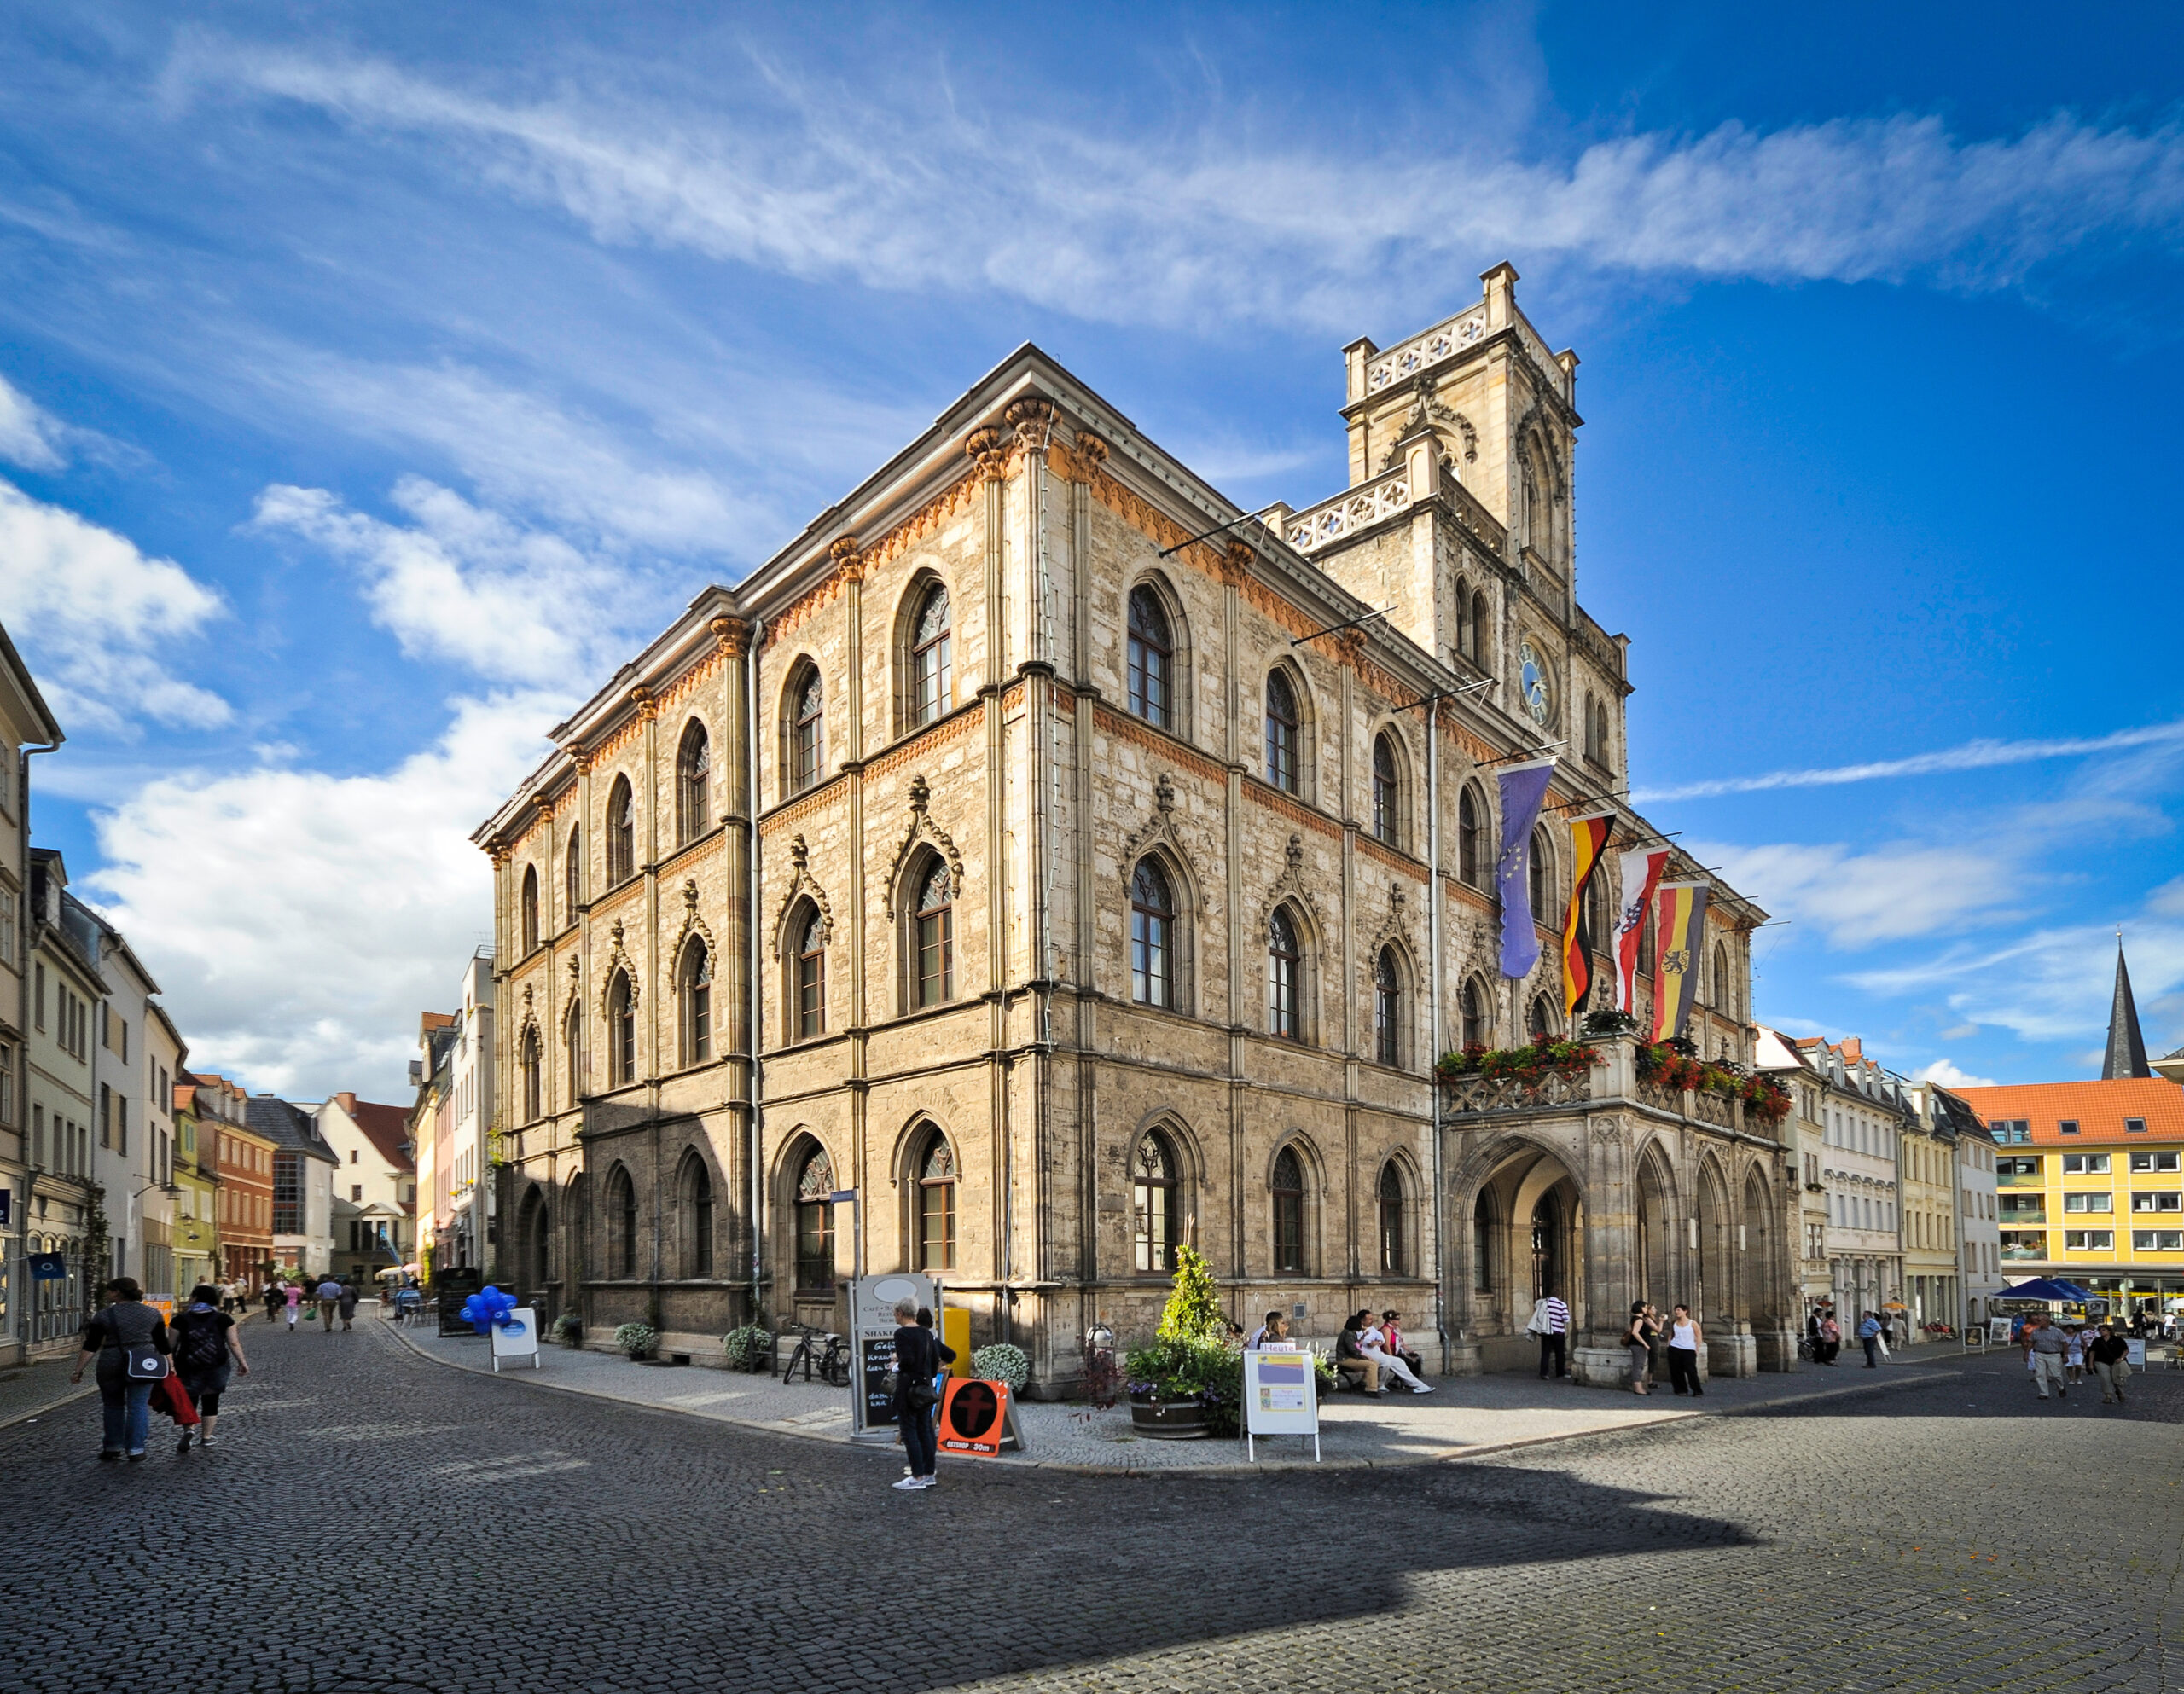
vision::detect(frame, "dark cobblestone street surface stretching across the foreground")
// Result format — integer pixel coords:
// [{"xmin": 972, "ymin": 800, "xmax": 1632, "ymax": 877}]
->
[{"xmin": 0, "ymin": 1325, "xmax": 2184, "ymax": 1694}]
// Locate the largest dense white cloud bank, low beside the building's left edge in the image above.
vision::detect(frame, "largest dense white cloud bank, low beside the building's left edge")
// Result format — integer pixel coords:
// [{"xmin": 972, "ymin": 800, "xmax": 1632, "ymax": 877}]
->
[{"xmin": 87, "ymin": 694, "xmax": 568, "ymax": 1098}]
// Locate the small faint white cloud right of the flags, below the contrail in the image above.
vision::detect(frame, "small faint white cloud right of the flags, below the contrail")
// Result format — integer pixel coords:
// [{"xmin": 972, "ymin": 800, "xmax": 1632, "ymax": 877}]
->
[{"xmin": 1693, "ymin": 843, "xmax": 2018, "ymax": 948}]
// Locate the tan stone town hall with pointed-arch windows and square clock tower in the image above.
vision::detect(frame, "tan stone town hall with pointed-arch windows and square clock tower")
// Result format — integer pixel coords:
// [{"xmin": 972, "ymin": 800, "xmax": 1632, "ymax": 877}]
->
[{"xmin": 479, "ymin": 266, "xmax": 1793, "ymax": 1389}]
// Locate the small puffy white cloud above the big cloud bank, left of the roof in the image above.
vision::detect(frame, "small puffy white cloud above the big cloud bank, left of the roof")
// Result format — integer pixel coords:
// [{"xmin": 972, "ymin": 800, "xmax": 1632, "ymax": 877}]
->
[{"xmin": 251, "ymin": 476, "xmax": 653, "ymax": 687}]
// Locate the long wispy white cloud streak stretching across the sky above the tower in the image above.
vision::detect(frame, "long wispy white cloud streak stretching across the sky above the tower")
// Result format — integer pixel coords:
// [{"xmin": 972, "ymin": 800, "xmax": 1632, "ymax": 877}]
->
[{"xmin": 192, "ymin": 39, "xmax": 2184, "ymax": 328}]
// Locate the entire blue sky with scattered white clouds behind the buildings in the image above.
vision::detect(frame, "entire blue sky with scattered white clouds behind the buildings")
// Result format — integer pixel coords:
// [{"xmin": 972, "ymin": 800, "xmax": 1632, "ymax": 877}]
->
[{"xmin": 0, "ymin": 4, "xmax": 2184, "ymax": 1098}]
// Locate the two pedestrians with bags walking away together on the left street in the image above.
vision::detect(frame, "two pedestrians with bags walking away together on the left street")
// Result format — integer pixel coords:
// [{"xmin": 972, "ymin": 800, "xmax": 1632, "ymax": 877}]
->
[{"xmin": 67, "ymin": 1277, "xmax": 251, "ymax": 1465}]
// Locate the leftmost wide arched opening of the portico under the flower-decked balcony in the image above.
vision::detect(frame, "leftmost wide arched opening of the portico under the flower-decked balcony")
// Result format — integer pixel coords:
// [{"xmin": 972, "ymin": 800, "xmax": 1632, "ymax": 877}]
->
[{"xmin": 1459, "ymin": 1146, "xmax": 1586, "ymax": 1371}]
